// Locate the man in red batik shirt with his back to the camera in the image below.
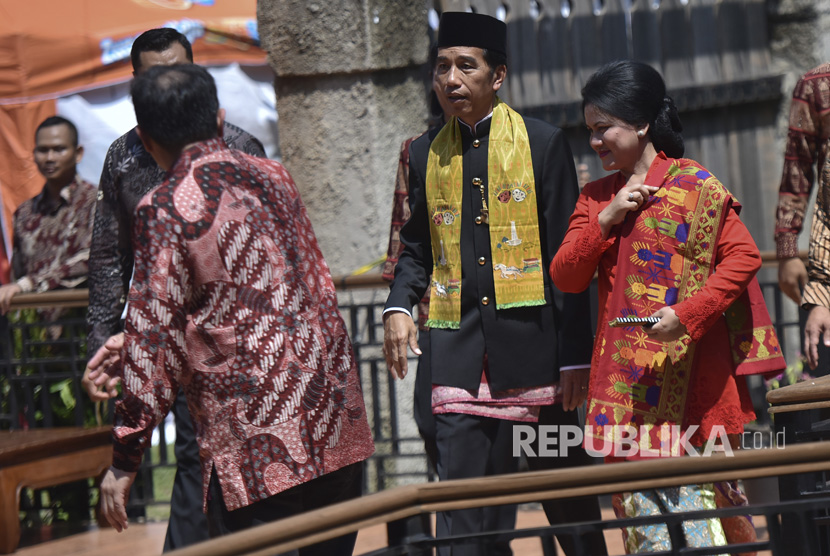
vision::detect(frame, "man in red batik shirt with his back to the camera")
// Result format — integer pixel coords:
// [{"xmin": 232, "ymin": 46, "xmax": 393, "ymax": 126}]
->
[{"xmin": 101, "ymin": 64, "xmax": 373, "ymax": 555}]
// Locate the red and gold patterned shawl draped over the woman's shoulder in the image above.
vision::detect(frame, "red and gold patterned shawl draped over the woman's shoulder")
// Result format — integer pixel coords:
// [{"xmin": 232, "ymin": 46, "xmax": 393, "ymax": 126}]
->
[{"xmin": 586, "ymin": 155, "xmax": 782, "ymax": 456}]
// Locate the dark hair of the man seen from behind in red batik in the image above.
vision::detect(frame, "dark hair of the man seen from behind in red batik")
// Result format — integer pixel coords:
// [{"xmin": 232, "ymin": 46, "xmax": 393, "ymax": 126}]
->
[{"xmin": 130, "ymin": 64, "xmax": 219, "ymax": 151}]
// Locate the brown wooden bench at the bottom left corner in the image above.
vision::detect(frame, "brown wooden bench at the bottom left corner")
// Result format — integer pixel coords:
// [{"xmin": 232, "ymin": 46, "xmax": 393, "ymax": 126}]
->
[{"xmin": 0, "ymin": 426, "xmax": 112, "ymax": 554}]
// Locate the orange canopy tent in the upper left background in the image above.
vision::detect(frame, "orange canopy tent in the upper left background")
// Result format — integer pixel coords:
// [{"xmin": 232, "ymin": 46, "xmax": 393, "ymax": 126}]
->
[{"xmin": 0, "ymin": 0, "xmax": 266, "ymax": 283}]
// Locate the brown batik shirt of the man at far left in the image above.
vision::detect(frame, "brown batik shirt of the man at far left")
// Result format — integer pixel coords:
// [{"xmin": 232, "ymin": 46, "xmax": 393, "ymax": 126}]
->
[{"xmin": 12, "ymin": 177, "xmax": 97, "ymax": 292}]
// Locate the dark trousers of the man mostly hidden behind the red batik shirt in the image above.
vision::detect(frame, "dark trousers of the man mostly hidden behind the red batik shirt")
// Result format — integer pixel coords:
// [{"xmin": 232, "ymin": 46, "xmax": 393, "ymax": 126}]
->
[{"xmin": 164, "ymin": 389, "xmax": 210, "ymax": 552}]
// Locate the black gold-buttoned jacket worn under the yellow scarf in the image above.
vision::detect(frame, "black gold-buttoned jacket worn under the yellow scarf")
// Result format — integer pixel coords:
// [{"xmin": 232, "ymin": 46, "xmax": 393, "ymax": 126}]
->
[{"xmin": 386, "ymin": 113, "xmax": 593, "ymax": 390}]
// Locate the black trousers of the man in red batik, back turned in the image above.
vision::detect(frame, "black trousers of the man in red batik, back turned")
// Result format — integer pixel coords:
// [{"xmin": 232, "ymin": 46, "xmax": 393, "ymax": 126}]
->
[{"xmin": 208, "ymin": 462, "xmax": 363, "ymax": 556}]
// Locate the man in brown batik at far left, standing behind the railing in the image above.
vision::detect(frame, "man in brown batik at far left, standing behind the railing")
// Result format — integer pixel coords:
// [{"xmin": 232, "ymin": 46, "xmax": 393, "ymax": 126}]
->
[{"xmin": 0, "ymin": 116, "xmax": 96, "ymax": 320}]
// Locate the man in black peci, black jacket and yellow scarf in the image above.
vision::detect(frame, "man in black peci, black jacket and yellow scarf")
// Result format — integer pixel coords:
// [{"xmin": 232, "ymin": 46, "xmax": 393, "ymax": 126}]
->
[{"xmin": 384, "ymin": 12, "xmax": 606, "ymax": 554}]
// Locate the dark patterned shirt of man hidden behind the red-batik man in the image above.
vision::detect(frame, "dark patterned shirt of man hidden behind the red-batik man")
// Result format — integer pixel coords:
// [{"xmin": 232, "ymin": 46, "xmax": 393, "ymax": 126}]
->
[{"xmin": 87, "ymin": 122, "xmax": 265, "ymax": 354}]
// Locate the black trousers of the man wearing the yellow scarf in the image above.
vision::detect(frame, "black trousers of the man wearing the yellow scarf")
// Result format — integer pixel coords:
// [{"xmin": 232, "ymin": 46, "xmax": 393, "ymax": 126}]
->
[{"xmin": 435, "ymin": 404, "xmax": 608, "ymax": 556}]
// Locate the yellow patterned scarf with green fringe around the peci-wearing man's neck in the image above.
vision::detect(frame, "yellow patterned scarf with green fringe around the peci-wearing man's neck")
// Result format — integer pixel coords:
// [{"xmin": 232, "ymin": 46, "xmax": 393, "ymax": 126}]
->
[{"xmin": 426, "ymin": 98, "xmax": 545, "ymax": 328}]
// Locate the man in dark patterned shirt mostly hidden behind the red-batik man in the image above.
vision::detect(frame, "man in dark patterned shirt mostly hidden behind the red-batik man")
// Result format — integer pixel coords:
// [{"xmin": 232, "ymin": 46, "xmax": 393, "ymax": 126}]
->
[{"xmin": 84, "ymin": 28, "xmax": 265, "ymax": 552}]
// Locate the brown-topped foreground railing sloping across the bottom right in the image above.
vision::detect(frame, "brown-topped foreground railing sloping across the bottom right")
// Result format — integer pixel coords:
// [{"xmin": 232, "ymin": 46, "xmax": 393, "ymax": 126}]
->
[{"xmin": 164, "ymin": 442, "xmax": 830, "ymax": 556}]
